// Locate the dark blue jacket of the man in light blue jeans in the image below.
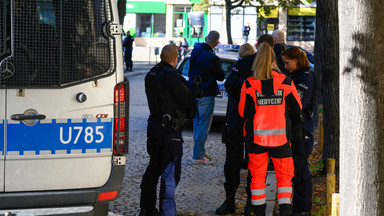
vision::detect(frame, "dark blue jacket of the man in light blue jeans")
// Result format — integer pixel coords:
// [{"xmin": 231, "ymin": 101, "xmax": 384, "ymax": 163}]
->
[{"xmin": 188, "ymin": 43, "xmax": 225, "ymax": 97}]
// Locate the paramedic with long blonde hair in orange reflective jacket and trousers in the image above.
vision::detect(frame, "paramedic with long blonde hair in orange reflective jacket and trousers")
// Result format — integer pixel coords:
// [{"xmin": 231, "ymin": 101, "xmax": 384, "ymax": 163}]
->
[{"xmin": 239, "ymin": 43, "xmax": 301, "ymax": 216}]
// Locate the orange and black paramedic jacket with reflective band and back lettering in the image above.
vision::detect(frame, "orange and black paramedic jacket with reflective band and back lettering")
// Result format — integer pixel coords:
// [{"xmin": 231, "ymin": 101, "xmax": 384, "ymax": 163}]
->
[{"xmin": 239, "ymin": 71, "xmax": 302, "ymax": 147}]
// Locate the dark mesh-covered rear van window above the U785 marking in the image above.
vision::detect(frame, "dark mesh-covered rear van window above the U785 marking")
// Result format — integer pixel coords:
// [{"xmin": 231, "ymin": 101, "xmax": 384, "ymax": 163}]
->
[{"xmin": 0, "ymin": 0, "xmax": 114, "ymax": 88}]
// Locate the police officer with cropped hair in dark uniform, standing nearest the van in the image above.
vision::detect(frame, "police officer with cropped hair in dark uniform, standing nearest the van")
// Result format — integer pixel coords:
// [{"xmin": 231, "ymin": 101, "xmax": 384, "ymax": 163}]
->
[{"xmin": 140, "ymin": 44, "xmax": 200, "ymax": 216}]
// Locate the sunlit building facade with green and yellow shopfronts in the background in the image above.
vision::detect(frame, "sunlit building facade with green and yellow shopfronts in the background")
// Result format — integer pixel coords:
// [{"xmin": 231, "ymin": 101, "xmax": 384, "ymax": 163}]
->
[{"xmin": 123, "ymin": 0, "xmax": 316, "ymax": 51}]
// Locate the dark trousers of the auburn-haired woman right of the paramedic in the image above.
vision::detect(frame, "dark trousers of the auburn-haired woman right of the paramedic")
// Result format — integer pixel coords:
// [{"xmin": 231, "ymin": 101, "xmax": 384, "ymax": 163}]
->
[{"xmin": 292, "ymin": 132, "xmax": 314, "ymax": 212}]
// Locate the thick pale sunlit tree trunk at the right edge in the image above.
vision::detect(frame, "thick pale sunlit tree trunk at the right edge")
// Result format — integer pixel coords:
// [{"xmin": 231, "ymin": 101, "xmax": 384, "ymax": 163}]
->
[{"xmin": 339, "ymin": 0, "xmax": 384, "ymax": 216}]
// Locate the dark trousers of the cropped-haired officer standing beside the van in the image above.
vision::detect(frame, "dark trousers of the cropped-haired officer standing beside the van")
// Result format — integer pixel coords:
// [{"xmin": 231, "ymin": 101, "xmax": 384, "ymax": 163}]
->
[{"xmin": 140, "ymin": 117, "xmax": 183, "ymax": 216}]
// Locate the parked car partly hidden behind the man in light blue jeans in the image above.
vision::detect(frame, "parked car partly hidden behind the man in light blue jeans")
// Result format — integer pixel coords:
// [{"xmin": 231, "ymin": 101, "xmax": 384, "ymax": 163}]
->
[{"xmin": 176, "ymin": 51, "xmax": 238, "ymax": 117}]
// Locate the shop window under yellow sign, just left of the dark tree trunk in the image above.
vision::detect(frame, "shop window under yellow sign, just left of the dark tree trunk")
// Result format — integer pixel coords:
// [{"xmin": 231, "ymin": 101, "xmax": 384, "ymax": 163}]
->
[{"xmin": 287, "ymin": 8, "xmax": 316, "ymax": 41}]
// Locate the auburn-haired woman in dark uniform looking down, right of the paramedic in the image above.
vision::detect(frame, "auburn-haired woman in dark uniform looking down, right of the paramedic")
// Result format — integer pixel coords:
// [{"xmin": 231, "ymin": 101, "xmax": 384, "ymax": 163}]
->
[{"xmin": 281, "ymin": 47, "xmax": 316, "ymax": 216}]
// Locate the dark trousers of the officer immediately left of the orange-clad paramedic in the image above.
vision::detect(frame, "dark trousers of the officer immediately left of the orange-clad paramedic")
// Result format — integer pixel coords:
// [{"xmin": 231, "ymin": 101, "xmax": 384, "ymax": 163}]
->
[{"xmin": 224, "ymin": 136, "xmax": 250, "ymax": 201}]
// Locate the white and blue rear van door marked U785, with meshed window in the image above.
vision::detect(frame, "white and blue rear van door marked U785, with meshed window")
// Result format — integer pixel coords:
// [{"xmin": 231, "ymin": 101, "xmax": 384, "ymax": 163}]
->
[{"xmin": 0, "ymin": 0, "xmax": 116, "ymax": 192}]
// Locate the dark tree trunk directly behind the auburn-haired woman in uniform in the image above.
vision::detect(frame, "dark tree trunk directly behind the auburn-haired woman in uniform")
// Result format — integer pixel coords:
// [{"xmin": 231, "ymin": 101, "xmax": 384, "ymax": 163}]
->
[{"xmin": 315, "ymin": 0, "xmax": 340, "ymax": 173}]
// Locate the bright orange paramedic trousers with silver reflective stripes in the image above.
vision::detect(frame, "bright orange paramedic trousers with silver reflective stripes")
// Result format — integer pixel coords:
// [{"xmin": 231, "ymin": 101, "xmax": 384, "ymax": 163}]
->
[{"xmin": 247, "ymin": 143, "xmax": 294, "ymax": 215}]
